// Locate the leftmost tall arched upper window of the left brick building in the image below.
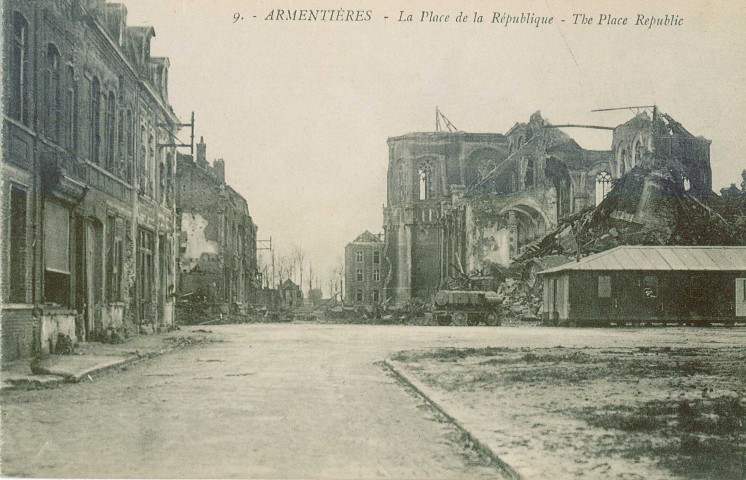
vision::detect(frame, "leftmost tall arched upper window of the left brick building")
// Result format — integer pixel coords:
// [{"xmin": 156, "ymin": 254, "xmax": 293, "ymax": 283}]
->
[{"xmin": 8, "ymin": 12, "xmax": 29, "ymax": 125}]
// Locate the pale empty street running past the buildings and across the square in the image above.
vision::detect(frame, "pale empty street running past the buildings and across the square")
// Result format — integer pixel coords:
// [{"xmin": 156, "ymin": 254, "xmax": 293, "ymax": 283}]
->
[{"xmin": 2, "ymin": 324, "xmax": 743, "ymax": 478}]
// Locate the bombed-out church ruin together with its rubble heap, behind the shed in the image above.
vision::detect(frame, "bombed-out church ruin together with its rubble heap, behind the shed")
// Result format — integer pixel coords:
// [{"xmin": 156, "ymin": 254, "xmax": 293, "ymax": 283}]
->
[{"xmin": 384, "ymin": 107, "xmax": 746, "ymax": 321}]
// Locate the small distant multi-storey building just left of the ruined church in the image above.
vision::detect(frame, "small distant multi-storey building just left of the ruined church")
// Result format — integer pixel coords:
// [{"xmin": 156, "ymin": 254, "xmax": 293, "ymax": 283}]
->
[{"xmin": 345, "ymin": 230, "xmax": 387, "ymax": 305}]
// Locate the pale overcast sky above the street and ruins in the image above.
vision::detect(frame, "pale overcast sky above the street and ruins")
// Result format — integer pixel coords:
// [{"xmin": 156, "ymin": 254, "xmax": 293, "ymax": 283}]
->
[{"xmin": 123, "ymin": 0, "xmax": 746, "ymax": 286}]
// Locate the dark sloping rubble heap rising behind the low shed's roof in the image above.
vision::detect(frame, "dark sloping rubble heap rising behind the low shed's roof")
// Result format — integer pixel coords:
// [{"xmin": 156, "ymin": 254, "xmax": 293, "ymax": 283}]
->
[{"xmin": 517, "ymin": 165, "xmax": 746, "ymax": 262}]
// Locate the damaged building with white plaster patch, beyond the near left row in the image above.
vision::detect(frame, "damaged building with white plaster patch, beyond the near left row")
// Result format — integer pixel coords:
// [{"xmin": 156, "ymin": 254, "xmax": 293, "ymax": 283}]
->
[{"xmin": 176, "ymin": 139, "xmax": 260, "ymax": 311}]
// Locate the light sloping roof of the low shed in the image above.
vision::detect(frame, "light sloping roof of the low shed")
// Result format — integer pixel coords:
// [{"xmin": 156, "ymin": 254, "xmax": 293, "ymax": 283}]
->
[{"xmin": 539, "ymin": 245, "xmax": 746, "ymax": 274}]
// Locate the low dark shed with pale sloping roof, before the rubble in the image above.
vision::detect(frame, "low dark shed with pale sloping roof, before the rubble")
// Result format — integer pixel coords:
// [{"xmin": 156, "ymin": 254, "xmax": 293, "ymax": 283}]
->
[{"xmin": 540, "ymin": 246, "xmax": 746, "ymax": 325}]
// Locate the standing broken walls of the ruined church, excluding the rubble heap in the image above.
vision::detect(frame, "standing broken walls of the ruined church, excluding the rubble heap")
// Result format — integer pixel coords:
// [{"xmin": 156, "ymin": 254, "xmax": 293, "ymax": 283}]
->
[{"xmin": 383, "ymin": 107, "xmax": 712, "ymax": 302}]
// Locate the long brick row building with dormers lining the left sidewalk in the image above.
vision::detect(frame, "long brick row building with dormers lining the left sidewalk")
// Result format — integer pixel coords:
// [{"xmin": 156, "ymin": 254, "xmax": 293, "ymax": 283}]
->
[{"xmin": 0, "ymin": 0, "xmax": 180, "ymax": 361}]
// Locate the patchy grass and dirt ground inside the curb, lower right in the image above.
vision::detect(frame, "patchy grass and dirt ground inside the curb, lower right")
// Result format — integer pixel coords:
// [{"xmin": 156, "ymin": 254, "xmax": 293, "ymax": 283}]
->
[{"xmin": 392, "ymin": 347, "xmax": 746, "ymax": 480}]
